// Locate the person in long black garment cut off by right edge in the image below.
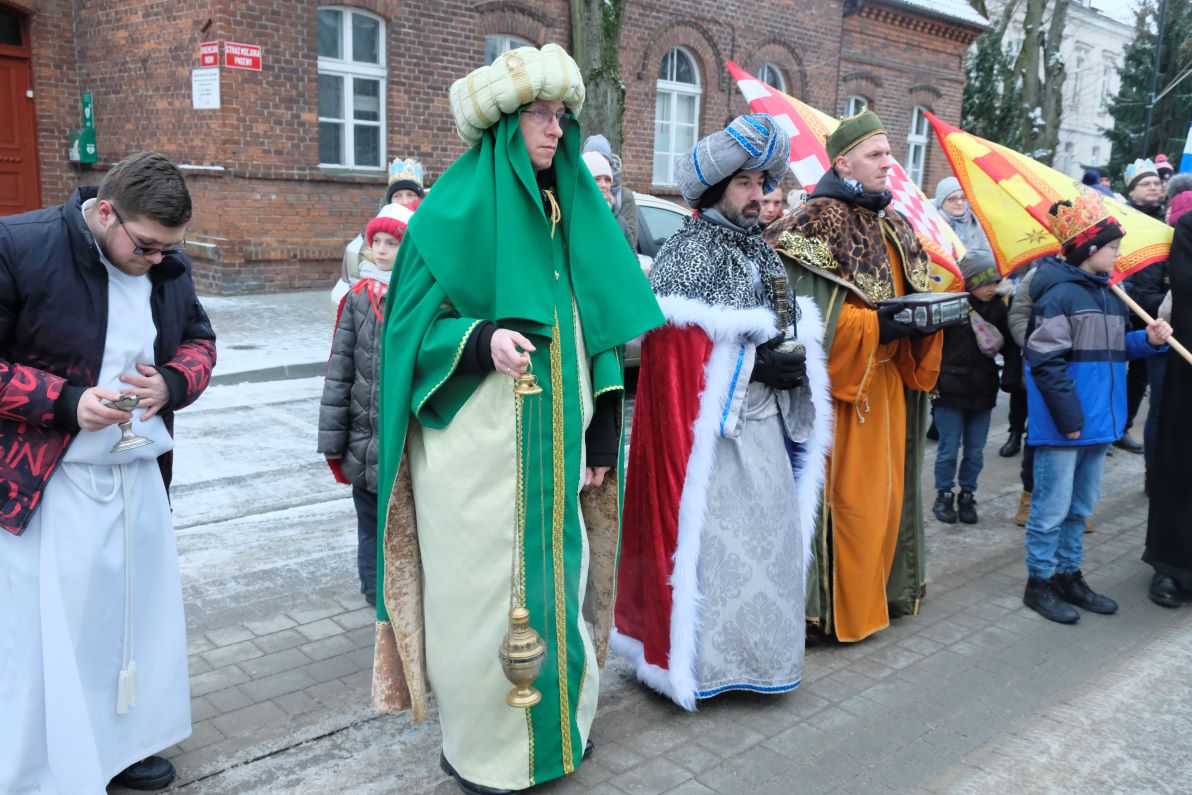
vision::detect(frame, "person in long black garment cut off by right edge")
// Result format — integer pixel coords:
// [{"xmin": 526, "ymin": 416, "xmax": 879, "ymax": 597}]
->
[{"xmin": 1142, "ymin": 183, "xmax": 1192, "ymax": 607}]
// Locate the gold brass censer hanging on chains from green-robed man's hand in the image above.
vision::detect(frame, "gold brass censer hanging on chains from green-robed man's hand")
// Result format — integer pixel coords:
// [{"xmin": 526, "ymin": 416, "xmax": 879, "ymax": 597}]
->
[{"xmin": 497, "ymin": 365, "xmax": 546, "ymax": 709}]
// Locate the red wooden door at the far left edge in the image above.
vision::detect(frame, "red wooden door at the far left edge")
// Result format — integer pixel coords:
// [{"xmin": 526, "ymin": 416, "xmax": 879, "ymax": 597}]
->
[{"xmin": 0, "ymin": 8, "xmax": 42, "ymax": 216}]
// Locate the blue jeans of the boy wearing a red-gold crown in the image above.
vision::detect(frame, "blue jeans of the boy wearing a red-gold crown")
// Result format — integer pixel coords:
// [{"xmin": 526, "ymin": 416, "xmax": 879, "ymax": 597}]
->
[{"xmin": 1026, "ymin": 445, "xmax": 1110, "ymax": 579}]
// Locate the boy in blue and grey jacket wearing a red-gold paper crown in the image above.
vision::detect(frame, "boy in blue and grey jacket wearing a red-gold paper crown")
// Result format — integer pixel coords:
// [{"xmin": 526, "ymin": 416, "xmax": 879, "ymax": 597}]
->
[{"xmin": 1023, "ymin": 195, "xmax": 1172, "ymax": 623}]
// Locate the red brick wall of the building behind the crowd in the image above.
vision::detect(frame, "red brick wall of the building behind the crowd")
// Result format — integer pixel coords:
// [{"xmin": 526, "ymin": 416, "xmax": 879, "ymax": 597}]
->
[{"xmin": 21, "ymin": 0, "xmax": 971, "ymax": 293}]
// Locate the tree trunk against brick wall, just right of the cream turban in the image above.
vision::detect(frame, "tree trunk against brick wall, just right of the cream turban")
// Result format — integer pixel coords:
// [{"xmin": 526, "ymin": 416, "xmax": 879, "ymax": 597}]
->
[{"xmin": 571, "ymin": 0, "xmax": 626, "ymax": 153}]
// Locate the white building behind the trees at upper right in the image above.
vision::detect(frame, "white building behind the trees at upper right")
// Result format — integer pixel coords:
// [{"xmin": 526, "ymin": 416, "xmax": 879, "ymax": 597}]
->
[{"xmin": 991, "ymin": 0, "xmax": 1134, "ymax": 180}]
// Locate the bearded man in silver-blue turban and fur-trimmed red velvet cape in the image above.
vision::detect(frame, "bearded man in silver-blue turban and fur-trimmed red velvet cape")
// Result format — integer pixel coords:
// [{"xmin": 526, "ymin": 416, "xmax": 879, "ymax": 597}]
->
[{"xmin": 613, "ymin": 114, "xmax": 832, "ymax": 709}]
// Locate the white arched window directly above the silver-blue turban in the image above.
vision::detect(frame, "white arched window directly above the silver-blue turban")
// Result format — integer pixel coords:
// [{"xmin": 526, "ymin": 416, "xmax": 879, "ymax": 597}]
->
[{"xmin": 653, "ymin": 46, "xmax": 703, "ymax": 185}]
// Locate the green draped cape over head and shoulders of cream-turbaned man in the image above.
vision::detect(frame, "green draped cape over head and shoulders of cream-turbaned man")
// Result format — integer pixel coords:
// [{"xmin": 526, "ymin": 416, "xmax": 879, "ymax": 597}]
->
[{"xmin": 377, "ymin": 114, "xmax": 665, "ymax": 621}]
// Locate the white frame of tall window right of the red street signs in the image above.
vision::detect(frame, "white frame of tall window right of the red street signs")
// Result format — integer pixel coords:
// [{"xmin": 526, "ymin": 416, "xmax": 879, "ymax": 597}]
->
[{"xmin": 316, "ymin": 6, "xmax": 389, "ymax": 172}]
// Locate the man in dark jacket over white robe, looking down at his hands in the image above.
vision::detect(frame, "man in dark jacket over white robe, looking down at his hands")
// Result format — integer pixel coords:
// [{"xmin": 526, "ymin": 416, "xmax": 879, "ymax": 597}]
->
[{"xmin": 0, "ymin": 153, "xmax": 216, "ymax": 793}]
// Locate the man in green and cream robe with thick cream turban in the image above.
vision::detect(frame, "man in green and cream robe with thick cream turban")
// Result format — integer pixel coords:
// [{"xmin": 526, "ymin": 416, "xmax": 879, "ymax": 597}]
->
[{"xmin": 373, "ymin": 44, "xmax": 663, "ymax": 793}]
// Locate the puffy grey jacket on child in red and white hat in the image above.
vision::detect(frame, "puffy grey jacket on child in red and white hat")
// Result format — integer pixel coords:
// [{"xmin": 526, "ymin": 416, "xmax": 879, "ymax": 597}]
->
[{"xmin": 318, "ymin": 286, "xmax": 384, "ymax": 492}]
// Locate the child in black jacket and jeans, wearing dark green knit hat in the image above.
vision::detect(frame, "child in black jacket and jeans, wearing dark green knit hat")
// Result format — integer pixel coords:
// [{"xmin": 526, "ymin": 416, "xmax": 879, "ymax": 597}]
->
[{"xmin": 931, "ymin": 249, "xmax": 1018, "ymax": 524}]
